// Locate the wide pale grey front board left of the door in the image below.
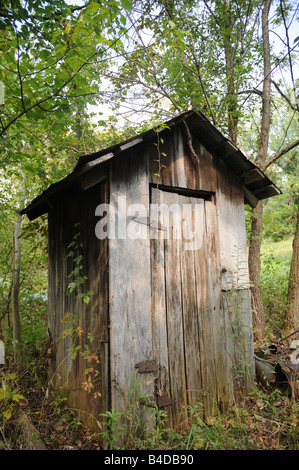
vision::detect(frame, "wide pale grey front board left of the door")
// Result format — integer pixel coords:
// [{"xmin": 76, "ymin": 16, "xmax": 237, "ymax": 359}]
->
[{"xmin": 109, "ymin": 150, "xmax": 154, "ymax": 426}]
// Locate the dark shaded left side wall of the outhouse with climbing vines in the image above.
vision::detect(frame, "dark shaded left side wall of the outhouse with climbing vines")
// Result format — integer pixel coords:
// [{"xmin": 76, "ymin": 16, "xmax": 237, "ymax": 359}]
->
[{"xmin": 48, "ymin": 184, "xmax": 110, "ymax": 430}]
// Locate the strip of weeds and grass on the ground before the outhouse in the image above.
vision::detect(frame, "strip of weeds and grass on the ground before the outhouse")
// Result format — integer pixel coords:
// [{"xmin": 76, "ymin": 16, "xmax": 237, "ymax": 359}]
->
[{"xmin": 0, "ymin": 356, "xmax": 299, "ymax": 451}]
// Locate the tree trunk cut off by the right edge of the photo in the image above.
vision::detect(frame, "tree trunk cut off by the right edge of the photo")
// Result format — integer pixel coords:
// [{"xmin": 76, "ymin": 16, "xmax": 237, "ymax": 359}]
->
[{"xmin": 285, "ymin": 213, "xmax": 299, "ymax": 339}]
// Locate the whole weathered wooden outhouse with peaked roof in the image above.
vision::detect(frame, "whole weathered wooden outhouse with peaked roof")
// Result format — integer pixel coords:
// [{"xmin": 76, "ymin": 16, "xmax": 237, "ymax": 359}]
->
[{"xmin": 23, "ymin": 111, "xmax": 280, "ymax": 434}]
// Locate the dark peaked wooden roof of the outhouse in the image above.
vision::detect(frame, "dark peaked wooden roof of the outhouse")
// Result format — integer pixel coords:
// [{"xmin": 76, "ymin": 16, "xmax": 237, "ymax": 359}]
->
[{"xmin": 21, "ymin": 110, "xmax": 281, "ymax": 220}]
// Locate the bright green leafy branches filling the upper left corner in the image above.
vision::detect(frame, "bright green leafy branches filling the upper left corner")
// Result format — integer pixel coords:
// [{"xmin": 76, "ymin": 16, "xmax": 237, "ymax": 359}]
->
[{"xmin": 0, "ymin": 0, "xmax": 135, "ymax": 198}]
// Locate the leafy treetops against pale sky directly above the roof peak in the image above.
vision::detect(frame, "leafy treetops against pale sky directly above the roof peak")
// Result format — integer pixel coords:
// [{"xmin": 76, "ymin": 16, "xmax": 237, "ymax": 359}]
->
[{"xmin": 110, "ymin": 0, "xmax": 270, "ymax": 132}]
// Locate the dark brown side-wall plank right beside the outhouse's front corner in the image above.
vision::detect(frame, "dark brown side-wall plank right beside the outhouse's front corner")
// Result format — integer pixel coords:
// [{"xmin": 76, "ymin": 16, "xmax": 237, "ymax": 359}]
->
[{"xmin": 81, "ymin": 183, "xmax": 110, "ymax": 420}]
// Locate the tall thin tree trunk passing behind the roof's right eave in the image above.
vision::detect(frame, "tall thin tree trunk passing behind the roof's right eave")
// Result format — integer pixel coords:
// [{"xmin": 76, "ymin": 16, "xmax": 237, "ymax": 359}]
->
[{"xmin": 249, "ymin": 0, "xmax": 271, "ymax": 340}]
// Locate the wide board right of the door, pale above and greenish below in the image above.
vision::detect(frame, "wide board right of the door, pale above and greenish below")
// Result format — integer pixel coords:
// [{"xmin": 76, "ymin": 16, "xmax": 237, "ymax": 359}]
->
[{"xmin": 216, "ymin": 161, "xmax": 253, "ymax": 396}]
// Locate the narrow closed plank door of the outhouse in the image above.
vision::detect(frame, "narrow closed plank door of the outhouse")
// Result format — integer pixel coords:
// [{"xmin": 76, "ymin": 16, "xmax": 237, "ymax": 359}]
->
[{"xmin": 151, "ymin": 188, "xmax": 224, "ymax": 427}]
